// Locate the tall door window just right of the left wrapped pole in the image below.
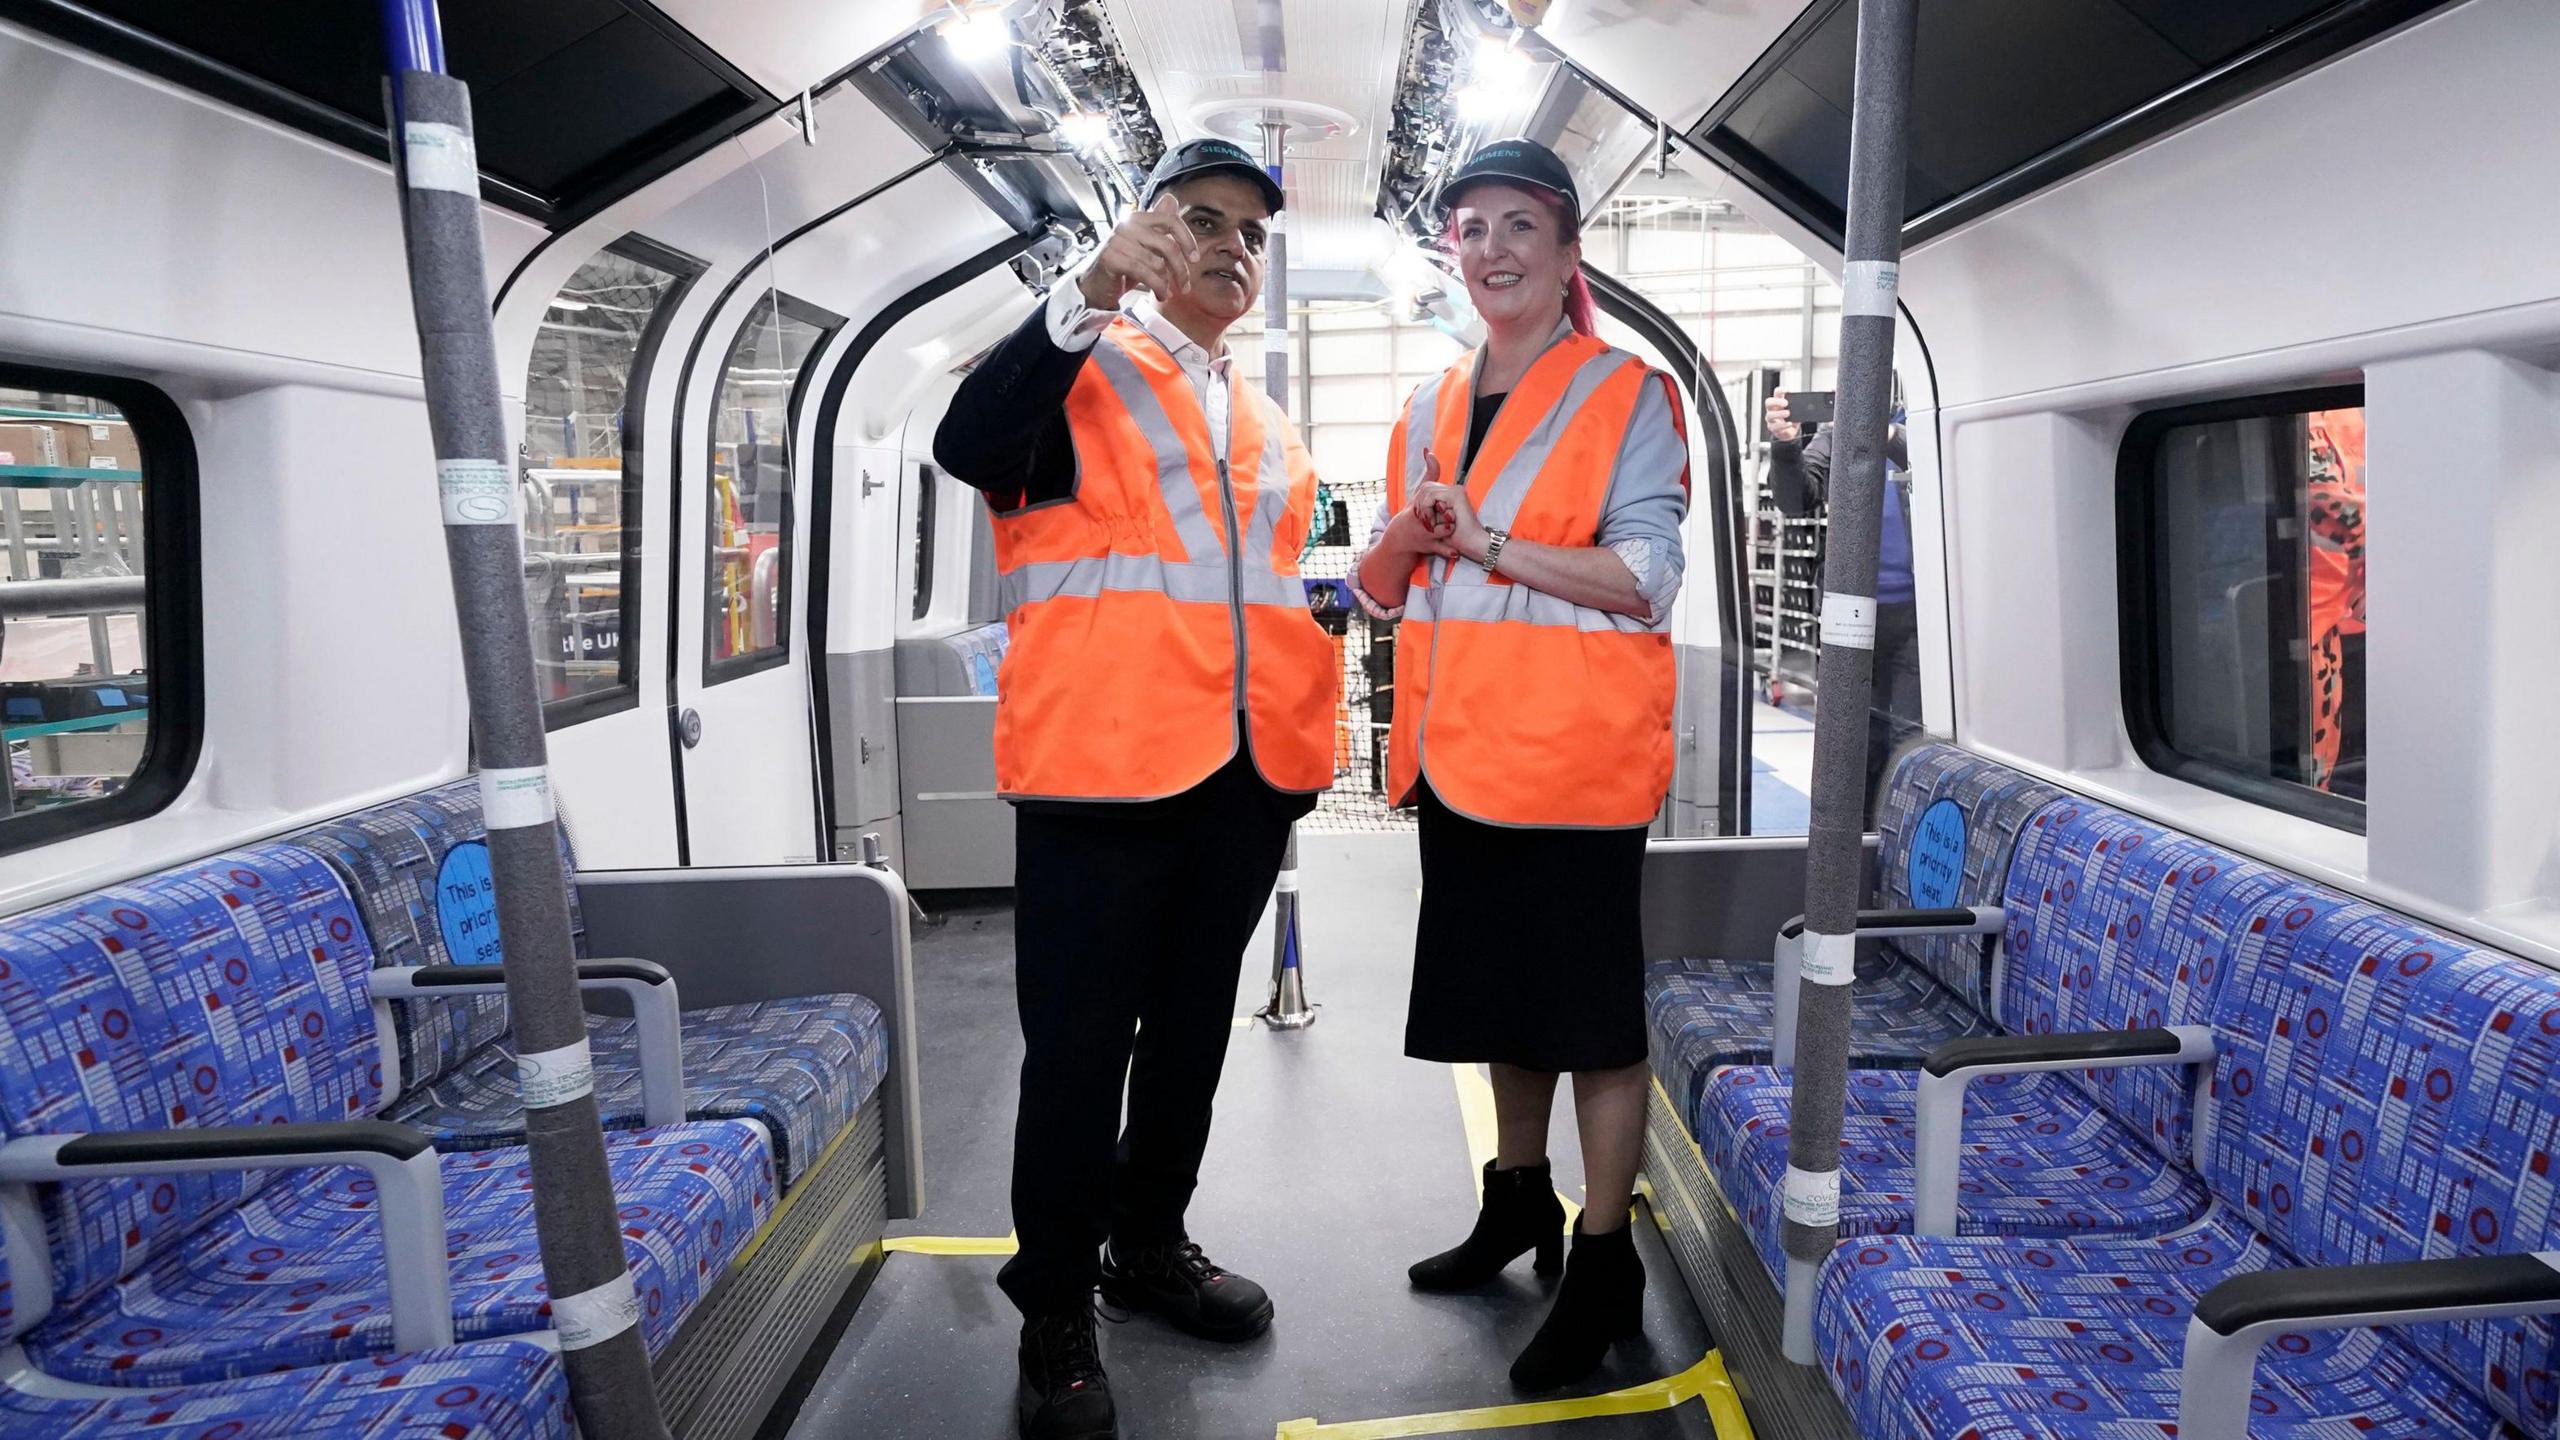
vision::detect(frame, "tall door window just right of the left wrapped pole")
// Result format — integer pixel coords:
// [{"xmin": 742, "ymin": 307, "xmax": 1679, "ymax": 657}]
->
[{"xmin": 522, "ymin": 241, "xmax": 699, "ymax": 728}]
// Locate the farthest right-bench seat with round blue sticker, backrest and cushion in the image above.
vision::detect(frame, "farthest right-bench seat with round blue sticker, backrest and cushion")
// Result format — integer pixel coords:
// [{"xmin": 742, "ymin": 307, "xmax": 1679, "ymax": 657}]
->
[{"xmin": 1646, "ymin": 740, "xmax": 2063, "ymax": 1133}]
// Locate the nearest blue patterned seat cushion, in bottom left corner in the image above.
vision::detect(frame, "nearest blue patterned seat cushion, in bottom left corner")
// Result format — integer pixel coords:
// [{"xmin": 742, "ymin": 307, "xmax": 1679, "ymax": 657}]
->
[{"xmin": 0, "ymin": 1340, "xmax": 571, "ymax": 1440}]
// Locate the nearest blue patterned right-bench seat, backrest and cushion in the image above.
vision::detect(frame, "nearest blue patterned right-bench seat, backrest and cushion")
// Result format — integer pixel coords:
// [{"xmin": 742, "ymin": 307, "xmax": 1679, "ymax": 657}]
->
[{"xmin": 1815, "ymin": 887, "xmax": 2560, "ymax": 1440}]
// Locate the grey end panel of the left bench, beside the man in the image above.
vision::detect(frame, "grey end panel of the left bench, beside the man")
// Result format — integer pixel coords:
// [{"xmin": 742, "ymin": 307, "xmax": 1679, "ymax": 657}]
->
[{"xmin": 579, "ymin": 863, "xmax": 924, "ymax": 1220}]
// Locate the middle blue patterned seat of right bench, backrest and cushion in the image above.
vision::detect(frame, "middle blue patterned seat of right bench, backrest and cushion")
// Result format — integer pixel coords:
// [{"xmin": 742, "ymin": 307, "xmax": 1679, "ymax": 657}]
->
[{"xmin": 1695, "ymin": 799, "xmax": 2299, "ymax": 1273}]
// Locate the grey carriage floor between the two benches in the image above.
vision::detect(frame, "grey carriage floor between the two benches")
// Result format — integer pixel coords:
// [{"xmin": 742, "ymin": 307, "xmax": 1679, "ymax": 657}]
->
[{"xmin": 788, "ymin": 835, "xmax": 1713, "ymax": 1440}]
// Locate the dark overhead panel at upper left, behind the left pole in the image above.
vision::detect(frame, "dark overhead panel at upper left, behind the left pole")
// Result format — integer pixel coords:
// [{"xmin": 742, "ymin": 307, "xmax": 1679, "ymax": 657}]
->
[{"xmin": 0, "ymin": 0, "xmax": 776, "ymax": 218}]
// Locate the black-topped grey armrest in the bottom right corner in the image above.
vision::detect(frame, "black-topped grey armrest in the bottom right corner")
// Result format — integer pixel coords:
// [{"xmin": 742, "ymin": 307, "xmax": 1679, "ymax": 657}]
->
[{"xmin": 2179, "ymin": 1250, "xmax": 2560, "ymax": 1440}]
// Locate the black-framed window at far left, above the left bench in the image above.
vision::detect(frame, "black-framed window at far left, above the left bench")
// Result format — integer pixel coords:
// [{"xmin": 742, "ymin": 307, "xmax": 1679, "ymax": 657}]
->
[{"xmin": 0, "ymin": 366, "xmax": 202, "ymax": 851}]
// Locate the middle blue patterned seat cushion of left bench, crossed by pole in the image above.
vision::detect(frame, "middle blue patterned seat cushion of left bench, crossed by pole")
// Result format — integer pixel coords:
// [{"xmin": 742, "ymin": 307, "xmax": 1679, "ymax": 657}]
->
[{"xmin": 26, "ymin": 1120, "xmax": 773, "ymax": 1386}]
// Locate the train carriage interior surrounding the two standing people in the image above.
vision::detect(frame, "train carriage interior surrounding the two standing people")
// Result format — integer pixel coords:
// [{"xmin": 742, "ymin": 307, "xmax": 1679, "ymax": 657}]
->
[{"xmin": 0, "ymin": 0, "xmax": 2560, "ymax": 1440}]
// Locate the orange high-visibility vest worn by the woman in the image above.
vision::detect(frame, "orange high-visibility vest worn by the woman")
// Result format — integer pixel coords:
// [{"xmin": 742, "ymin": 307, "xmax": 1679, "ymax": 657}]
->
[{"xmin": 1388, "ymin": 336, "xmax": 1679, "ymax": 828}]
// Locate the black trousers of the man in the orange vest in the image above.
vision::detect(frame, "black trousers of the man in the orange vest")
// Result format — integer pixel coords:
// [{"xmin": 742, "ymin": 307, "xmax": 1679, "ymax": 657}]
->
[{"xmin": 996, "ymin": 756, "xmax": 1311, "ymax": 1314}]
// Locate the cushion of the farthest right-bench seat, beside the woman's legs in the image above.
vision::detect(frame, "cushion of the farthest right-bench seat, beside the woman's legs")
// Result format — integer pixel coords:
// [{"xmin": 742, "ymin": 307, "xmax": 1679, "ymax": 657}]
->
[{"xmin": 1644, "ymin": 956, "xmax": 1992, "ymax": 1133}]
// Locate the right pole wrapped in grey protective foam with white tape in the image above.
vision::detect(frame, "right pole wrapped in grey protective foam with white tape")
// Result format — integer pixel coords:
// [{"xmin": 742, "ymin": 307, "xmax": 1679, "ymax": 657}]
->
[{"xmin": 1784, "ymin": 0, "xmax": 1917, "ymax": 1366}]
